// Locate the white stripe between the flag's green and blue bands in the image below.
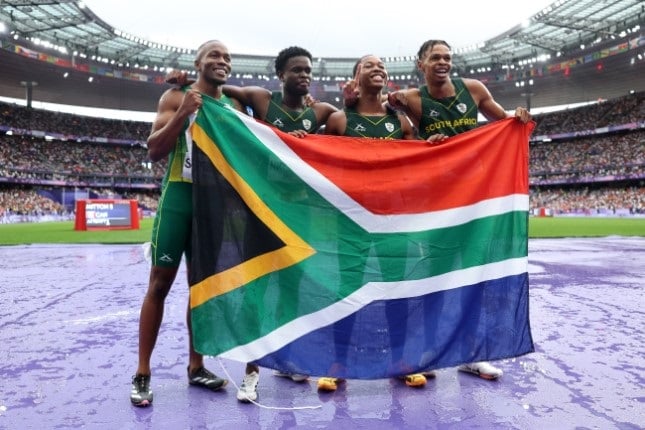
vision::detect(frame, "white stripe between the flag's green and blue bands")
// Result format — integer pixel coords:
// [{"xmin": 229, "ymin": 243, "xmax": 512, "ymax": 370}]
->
[{"xmin": 220, "ymin": 257, "xmax": 528, "ymax": 362}]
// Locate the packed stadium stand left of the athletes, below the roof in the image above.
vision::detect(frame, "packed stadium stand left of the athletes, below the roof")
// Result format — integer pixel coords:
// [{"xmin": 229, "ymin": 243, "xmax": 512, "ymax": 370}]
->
[{"xmin": 0, "ymin": 103, "xmax": 165, "ymax": 223}]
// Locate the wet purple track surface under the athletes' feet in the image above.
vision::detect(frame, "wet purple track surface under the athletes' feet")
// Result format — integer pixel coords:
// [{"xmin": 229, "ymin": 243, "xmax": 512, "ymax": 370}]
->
[{"xmin": 0, "ymin": 237, "xmax": 645, "ymax": 430}]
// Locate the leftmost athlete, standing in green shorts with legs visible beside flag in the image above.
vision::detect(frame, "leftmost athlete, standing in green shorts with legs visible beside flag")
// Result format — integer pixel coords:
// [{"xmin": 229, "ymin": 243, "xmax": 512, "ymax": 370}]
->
[{"xmin": 130, "ymin": 40, "xmax": 242, "ymax": 406}]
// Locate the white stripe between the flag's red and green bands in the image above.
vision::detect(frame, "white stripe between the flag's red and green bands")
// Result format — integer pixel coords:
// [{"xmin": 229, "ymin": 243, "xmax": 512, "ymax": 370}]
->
[{"xmin": 234, "ymin": 109, "xmax": 529, "ymax": 233}]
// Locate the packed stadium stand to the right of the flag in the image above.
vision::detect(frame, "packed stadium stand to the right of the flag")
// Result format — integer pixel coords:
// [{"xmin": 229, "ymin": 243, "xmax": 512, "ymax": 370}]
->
[{"xmin": 529, "ymin": 92, "xmax": 645, "ymax": 216}]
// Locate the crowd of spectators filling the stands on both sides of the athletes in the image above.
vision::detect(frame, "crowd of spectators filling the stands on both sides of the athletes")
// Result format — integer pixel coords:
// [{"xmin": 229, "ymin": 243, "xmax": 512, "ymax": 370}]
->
[{"xmin": 0, "ymin": 93, "xmax": 645, "ymax": 220}]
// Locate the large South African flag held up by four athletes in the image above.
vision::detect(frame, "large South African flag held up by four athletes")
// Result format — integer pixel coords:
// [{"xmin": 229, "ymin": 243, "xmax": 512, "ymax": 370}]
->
[{"xmin": 189, "ymin": 97, "xmax": 533, "ymax": 379}]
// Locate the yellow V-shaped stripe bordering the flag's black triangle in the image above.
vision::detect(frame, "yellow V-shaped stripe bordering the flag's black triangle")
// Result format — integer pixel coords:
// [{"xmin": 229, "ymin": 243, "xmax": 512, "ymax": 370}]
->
[{"xmin": 190, "ymin": 124, "xmax": 316, "ymax": 308}]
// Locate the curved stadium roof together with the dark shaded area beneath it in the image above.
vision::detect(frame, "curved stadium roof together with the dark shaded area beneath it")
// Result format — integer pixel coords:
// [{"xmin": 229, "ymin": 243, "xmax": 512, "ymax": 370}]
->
[{"xmin": 0, "ymin": 0, "xmax": 645, "ymax": 112}]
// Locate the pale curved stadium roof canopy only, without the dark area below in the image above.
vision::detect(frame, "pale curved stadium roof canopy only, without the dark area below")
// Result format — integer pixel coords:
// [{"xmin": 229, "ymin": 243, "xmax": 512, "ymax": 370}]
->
[{"xmin": 0, "ymin": 0, "xmax": 645, "ymax": 78}]
